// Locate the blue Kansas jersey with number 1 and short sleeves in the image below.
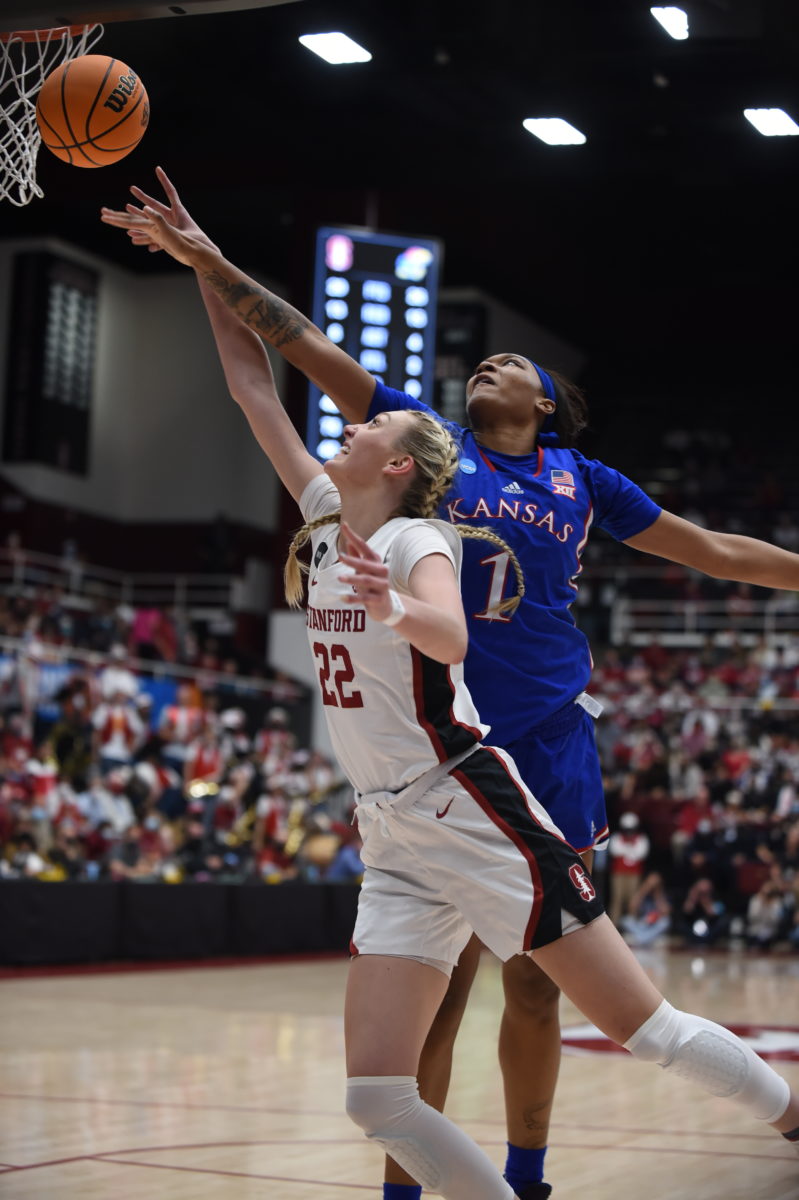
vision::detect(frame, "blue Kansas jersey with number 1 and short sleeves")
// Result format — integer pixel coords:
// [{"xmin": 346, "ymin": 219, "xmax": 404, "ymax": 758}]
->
[{"xmin": 367, "ymin": 383, "xmax": 661, "ymax": 745}]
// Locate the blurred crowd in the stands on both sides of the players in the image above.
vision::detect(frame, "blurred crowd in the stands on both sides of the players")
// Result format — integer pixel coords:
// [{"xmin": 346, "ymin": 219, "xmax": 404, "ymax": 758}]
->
[{"xmin": 0, "ymin": 470, "xmax": 799, "ymax": 950}]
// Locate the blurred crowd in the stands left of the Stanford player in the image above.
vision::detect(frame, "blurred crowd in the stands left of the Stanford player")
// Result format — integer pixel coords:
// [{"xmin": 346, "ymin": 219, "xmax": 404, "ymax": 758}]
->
[{"xmin": 0, "ymin": 589, "xmax": 362, "ymax": 883}]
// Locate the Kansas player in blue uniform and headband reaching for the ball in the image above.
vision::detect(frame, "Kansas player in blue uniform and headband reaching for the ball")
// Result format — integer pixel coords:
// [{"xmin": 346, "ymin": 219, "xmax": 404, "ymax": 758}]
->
[{"xmin": 106, "ymin": 173, "xmax": 799, "ymax": 1200}]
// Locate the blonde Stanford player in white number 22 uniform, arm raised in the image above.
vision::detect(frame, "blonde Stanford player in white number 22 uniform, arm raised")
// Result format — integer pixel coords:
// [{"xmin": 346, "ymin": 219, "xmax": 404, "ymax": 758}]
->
[{"xmin": 103, "ymin": 176, "xmax": 799, "ymax": 1200}]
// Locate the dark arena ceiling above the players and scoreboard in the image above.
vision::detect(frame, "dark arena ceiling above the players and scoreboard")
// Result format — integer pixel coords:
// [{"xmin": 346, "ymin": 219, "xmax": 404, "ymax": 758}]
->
[{"xmin": 0, "ymin": 0, "xmax": 799, "ymax": 429}]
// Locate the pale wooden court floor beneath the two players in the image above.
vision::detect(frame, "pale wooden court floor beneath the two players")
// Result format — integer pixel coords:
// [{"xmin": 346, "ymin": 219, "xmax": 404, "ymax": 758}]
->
[{"xmin": 0, "ymin": 949, "xmax": 799, "ymax": 1200}]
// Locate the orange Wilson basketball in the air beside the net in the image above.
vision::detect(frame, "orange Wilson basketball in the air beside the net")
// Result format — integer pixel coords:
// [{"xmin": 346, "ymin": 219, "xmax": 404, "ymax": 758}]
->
[{"xmin": 36, "ymin": 54, "xmax": 150, "ymax": 167}]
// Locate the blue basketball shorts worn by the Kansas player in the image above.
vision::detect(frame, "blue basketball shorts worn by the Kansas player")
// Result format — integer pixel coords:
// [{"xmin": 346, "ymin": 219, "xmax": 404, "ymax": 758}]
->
[{"xmin": 501, "ymin": 702, "xmax": 608, "ymax": 854}]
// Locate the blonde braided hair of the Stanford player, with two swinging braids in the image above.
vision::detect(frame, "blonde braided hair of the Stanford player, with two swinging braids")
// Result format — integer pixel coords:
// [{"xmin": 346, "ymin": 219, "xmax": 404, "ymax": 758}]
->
[{"xmin": 283, "ymin": 408, "xmax": 524, "ymax": 616}]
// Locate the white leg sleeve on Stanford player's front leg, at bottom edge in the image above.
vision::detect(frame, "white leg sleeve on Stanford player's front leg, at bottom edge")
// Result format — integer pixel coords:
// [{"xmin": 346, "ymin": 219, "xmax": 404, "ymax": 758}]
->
[{"xmin": 347, "ymin": 1075, "xmax": 515, "ymax": 1200}]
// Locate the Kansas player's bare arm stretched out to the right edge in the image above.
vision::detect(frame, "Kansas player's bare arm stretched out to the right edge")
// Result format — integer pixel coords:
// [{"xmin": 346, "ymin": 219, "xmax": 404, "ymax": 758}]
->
[{"xmin": 626, "ymin": 511, "xmax": 799, "ymax": 592}]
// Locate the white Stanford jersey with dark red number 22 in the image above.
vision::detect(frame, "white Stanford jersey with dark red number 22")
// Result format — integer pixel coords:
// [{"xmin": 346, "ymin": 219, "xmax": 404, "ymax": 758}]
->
[{"xmin": 300, "ymin": 475, "xmax": 488, "ymax": 793}]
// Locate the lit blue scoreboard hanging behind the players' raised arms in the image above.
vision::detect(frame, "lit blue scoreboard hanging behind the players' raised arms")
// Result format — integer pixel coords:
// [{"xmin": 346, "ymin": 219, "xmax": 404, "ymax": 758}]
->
[{"xmin": 306, "ymin": 227, "xmax": 441, "ymax": 462}]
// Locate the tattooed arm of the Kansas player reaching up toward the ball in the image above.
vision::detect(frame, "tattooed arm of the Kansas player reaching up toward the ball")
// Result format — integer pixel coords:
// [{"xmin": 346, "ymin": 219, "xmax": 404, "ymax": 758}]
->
[{"xmin": 101, "ymin": 180, "xmax": 374, "ymax": 421}]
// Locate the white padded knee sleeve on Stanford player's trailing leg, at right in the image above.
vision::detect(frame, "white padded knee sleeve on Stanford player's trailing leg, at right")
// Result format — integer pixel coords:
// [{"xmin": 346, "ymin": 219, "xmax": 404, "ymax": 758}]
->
[{"xmin": 624, "ymin": 1000, "xmax": 791, "ymax": 1122}]
